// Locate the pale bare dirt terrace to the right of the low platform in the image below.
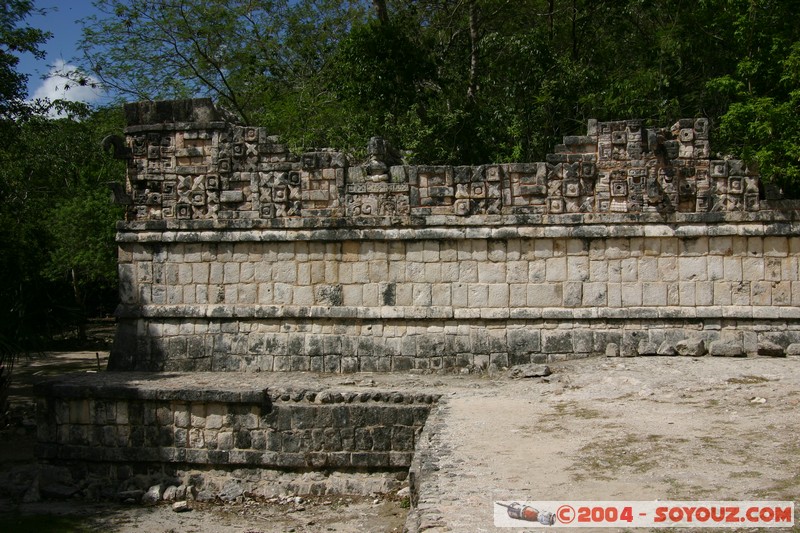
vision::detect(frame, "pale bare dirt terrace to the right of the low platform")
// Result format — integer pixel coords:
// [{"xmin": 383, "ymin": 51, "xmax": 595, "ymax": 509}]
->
[{"xmin": 423, "ymin": 356, "xmax": 800, "ymax": 532}]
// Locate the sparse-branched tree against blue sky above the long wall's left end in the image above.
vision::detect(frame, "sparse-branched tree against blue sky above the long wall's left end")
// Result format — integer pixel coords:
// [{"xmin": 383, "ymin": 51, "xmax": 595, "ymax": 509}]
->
[{"xmin": 82, "ymin": 0, "xmax": 365, "ymax": 123}]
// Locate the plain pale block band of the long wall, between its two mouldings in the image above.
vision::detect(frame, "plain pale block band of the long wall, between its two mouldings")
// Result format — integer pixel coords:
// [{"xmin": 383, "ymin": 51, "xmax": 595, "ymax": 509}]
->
[{"xmin": 115, "ymin": 236, "xmax": 800, "ymax": 310}]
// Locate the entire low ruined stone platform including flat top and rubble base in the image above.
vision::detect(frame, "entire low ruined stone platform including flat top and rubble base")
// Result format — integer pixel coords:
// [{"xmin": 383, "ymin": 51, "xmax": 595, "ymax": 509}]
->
[{"xmin": 35, "ymin": 372, "xmax": 440, "ymax": 497}]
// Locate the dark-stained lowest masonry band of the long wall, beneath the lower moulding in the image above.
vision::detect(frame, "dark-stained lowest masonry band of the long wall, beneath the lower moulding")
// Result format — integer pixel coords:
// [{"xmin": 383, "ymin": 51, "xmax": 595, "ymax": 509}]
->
[{"xmin": 119, "ymin": 316, "xmax": 800, "ymax": 373}]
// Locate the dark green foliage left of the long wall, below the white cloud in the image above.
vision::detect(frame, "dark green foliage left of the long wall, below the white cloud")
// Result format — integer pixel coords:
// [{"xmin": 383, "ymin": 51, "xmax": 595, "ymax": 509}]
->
[{"xmin": 0, "ymin": 104, "xmax": 124, "ymax": 351}]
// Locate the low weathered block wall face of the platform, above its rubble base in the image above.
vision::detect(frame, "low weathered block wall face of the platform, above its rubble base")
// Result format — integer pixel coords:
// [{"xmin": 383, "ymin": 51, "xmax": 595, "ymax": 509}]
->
[{"xmin": 36, "ymin": 374, "xmax": 438, "ymax": 471}]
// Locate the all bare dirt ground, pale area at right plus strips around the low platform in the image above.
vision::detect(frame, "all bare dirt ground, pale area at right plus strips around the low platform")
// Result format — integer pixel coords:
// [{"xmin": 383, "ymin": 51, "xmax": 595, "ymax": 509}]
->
[{"xmin": 0, "ymin": 352, "xmax": 800, "ymax": 533}]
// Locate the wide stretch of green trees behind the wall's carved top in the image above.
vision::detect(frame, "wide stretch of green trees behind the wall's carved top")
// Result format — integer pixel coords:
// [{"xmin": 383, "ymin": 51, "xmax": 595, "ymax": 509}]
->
[{"xmin": 72, "ymin": 0, "xmax": 800, "ymax": 182}]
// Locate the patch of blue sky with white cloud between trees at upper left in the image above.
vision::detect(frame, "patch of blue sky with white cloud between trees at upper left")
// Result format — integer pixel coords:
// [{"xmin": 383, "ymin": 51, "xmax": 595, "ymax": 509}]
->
[{"xmin": 18, "ymin": 0, "xmax": 104, "ymax": 103}]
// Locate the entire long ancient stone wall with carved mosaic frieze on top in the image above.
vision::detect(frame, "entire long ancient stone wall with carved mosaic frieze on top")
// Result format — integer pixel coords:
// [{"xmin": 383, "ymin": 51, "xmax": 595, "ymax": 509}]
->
[{"xmin": 110, "ymin": 100, "xmax": 800, "ymax": 372}]
